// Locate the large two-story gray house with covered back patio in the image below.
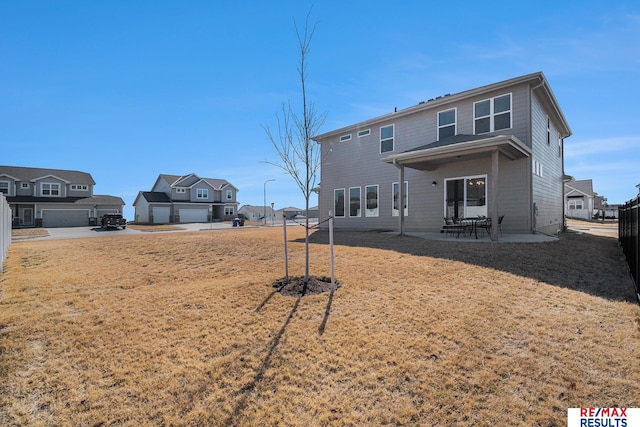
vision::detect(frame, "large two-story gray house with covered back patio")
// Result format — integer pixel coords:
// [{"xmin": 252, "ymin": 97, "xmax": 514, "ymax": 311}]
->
[{"xmin": 313, "ymin": 72, "xmax": 571, "ymax": 239}]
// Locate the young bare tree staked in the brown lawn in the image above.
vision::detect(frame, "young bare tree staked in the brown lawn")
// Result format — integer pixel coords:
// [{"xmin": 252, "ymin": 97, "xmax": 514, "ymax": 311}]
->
[{"xmin": 262, "ymin": 11, "xmax": 327, "ymax": 285}]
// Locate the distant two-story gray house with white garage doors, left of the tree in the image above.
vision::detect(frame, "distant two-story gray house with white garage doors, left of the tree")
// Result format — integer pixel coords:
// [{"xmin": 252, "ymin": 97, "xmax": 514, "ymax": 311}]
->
[{"xmin": 133, "ymin": 173, "xmax": 239, "ymax": 224}]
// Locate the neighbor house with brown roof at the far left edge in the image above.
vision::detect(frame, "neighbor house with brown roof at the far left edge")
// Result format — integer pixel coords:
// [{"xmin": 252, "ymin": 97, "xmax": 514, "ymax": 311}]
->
[{"xmin": 0, "ymin": 166, "xmax": 125, "ymax": 228}]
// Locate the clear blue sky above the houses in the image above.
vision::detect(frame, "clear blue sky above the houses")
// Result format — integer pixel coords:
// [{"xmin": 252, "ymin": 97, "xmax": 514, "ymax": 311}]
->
[{"xmin": 0, "ymin": 0, "xmax": 640, "ymax": 218}]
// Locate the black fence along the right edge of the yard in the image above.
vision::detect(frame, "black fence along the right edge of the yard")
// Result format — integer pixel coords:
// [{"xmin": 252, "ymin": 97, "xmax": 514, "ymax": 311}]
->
[{"xmin": 618, "ymin": 196, "xmax": 640, "ymax": 302}]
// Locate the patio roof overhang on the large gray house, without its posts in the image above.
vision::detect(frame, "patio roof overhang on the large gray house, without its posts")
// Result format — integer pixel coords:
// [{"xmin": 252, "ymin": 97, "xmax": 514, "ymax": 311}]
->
[{"xmin": 382, "ymin": 135, "xmax": 531, "ymax": 171}]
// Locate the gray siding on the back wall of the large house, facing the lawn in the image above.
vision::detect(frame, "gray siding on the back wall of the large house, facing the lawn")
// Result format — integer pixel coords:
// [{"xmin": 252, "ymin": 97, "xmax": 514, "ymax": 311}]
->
[{"xmin": 319, "ymin": 85, "xmax": 546, "ymax": 232}]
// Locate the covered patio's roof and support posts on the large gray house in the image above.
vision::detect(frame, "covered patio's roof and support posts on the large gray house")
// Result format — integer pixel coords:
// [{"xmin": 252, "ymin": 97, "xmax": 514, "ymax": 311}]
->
[{"xmin": 382, "ymin": 135, "xmax": 531, "ymax": 241}]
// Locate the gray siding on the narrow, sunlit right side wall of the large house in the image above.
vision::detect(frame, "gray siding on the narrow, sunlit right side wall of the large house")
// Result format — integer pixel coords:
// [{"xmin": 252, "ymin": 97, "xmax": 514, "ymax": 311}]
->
[{"xmin": 531, "ymin": 95, "xmax": 564, "ymax": 234}]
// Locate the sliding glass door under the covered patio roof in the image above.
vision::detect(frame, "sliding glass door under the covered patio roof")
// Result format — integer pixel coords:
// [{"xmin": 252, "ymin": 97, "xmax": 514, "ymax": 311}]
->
[{"xmin": 444, "ymin": 175, "xmax": 487, "ymax": 218}]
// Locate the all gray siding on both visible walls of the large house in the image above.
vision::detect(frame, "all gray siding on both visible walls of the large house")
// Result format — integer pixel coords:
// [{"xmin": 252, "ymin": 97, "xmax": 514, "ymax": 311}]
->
[{"xmin": 318, "ymin": 74, "xmax": 564, "ymax": 233}]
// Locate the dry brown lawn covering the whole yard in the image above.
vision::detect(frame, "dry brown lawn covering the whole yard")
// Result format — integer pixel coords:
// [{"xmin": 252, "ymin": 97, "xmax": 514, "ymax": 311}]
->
[{"xmin": 0, "ymin": 227, "xmax": 640, "ymax": 427}]
